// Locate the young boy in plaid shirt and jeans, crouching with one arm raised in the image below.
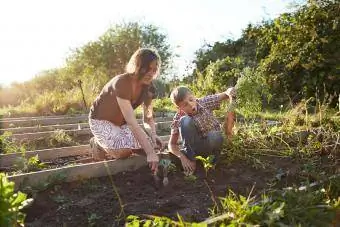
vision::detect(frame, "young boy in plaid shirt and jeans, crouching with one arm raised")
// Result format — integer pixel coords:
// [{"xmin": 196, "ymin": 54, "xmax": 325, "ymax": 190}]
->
[{"xmin": 168, "ymin": 86, "xmax": 236, "ymax": 175}]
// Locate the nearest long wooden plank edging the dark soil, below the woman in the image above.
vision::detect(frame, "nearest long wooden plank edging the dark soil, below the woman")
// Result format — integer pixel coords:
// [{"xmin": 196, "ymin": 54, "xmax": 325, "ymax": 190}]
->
[{"xmin": 8, "ymin": 156, "xmax": 147, "ymax": 189}]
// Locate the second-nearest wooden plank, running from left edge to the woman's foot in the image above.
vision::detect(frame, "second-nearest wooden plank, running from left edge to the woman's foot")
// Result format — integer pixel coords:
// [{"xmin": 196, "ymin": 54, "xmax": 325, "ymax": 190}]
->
[{"xmin": 0, "ymin": 144, "xmax": 90, "ymax": 167}]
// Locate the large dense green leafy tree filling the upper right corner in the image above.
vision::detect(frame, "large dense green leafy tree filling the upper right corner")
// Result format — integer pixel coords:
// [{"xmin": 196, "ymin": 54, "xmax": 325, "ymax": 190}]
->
[{"xmin": 248, "ymin": 0, "xmax": 340, "ymax": 106}]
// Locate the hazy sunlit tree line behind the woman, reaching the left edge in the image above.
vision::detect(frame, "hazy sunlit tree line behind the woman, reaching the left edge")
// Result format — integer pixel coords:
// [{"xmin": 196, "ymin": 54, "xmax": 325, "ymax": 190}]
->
[{"xmin": 0, "ymin": 22, "xmax": 172, "ymax": 114}]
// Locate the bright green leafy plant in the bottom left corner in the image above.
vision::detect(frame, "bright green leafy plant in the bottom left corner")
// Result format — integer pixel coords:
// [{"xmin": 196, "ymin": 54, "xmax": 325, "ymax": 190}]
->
[{"xmin": 0, "ymin": 173, "xmax": 33, "ymax": 226}]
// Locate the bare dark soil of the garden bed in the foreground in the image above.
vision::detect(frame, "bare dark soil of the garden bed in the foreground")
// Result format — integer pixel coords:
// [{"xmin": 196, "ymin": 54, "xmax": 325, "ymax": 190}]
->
[{"xmin": 24, "ymin": 153, "xmax": 298, "ymax": 226}]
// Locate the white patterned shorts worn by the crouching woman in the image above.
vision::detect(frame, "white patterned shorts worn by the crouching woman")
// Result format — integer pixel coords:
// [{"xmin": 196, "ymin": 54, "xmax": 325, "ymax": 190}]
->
[{"xmin": 89, "ymin": 118, "xmax": 147, "ymax": 150}]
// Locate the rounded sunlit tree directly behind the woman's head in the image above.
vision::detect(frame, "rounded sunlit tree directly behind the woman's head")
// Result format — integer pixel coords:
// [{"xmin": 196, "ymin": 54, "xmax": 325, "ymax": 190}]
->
[{"xmin": 67, "ymin": 22, "xmax": 172, "ymax": 87}]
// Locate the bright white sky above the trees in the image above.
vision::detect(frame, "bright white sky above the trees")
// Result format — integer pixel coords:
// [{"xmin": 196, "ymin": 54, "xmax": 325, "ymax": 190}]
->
[{"xmin": 0, "ymin": 0, "xmax": 290, "ymax": 86}]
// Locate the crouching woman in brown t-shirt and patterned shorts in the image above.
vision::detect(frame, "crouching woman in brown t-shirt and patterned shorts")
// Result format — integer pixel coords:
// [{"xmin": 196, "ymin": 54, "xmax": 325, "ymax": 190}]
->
[{"xmin": 89, "ymin": 48, "xmax": 163, "ymax": 172}]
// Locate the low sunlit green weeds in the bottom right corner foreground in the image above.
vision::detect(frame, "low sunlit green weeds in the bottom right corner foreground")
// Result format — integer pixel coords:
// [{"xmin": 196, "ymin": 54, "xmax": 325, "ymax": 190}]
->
[{"xmin": 205, "ymin": 182, "xmax": 340, "ymax": 226}]
